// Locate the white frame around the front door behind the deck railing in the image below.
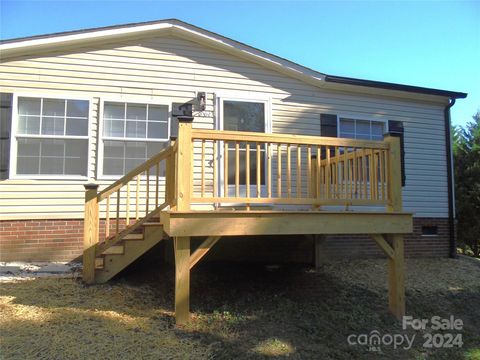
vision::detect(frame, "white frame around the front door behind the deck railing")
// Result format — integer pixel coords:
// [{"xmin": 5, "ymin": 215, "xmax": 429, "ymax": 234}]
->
[{"xmin": 215, "ymin": 92, "xmax": 272, "ymax": 197}]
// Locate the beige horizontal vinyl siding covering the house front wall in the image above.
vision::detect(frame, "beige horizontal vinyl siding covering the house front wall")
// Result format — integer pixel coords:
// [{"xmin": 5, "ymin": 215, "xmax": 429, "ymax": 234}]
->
[{"xmin": 0, "ymin": 37, "xmax": 448, "ymax": 219}]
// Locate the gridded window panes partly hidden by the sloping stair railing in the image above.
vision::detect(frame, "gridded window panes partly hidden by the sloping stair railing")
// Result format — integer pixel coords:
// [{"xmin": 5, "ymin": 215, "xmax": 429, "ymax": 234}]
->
[{"xmin": 102, "ymin": 101, "xmax": 170, "ymax": 176}]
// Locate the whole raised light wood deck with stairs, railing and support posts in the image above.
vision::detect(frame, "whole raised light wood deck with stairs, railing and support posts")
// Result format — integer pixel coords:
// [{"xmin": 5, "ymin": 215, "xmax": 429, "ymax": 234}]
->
[{"xmin": 83, "ymin": 118, "xmax": 412, "ymax": 324}]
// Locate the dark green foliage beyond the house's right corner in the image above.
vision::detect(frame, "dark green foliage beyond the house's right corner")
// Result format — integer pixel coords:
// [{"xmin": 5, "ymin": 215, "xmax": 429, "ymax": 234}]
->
[{"xmin": 452, "ymin": 111, "xmax": 480, "ymax": 257}]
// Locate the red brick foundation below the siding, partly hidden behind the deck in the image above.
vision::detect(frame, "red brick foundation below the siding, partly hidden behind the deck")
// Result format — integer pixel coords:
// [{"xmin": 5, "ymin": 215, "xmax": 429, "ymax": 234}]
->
[{"xmin": 0, "ymin": 218, "xmax": 449, "ymax": 262}]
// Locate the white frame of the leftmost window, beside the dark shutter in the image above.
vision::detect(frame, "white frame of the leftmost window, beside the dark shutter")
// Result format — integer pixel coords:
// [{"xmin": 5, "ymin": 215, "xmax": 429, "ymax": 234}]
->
[{"xmin": 8, "ymin": 92, "xmax": 93, "ymax": 180}]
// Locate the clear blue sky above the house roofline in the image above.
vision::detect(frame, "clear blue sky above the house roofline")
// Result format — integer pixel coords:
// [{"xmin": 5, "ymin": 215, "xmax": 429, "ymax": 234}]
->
[{"xmin": 0, "ymin": 0, "xmax": 480, "ymax": 125}]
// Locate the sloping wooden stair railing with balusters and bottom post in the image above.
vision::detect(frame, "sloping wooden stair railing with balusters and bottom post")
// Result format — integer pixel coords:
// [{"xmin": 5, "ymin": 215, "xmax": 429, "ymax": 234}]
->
[{"xmin": 83, "ymin": 141, "xmax": 177, "ymax": 283}]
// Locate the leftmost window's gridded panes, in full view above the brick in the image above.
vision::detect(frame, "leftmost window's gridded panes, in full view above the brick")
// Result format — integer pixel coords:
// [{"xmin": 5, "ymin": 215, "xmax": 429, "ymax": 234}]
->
[{"xmin": 12, "ymin": 96, "xmax": 90, "ymax": 178}]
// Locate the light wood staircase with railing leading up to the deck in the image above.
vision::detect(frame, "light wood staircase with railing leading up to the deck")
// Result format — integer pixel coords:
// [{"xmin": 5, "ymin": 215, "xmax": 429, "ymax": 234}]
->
[{"xmin": 83, "ymin": 141, "xmax": 176, "ymax": 284}]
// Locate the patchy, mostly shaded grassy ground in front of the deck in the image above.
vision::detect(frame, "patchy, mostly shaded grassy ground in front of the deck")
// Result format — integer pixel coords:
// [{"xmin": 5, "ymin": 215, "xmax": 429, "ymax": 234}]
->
[{"xmin": 0, "ymin": 259, "xmax": 480, "ymax": 360}]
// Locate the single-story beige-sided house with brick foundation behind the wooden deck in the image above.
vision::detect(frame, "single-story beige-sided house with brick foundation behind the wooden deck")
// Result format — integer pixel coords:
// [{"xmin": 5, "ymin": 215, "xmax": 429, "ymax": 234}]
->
[{"xmin": 0, "ymin": 19, "xmax": 466, "ymax": 268}]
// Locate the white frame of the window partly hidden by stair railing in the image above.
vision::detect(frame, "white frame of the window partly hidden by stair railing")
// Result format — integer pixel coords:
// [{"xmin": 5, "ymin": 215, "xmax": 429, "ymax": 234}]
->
[{"xmin": 97, "ymin": 98, "xmax": 172, "ymax": 180}]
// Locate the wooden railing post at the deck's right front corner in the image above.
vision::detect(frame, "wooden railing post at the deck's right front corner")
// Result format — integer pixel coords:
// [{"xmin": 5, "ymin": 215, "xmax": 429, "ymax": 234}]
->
[{"xmin": 384, "ymin": 134, "xmax": 402, "ymax": 212}]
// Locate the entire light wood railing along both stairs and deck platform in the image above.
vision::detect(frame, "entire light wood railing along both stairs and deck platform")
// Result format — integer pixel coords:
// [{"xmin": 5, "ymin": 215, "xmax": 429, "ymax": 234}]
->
[{"xmin": 83, "ymin": 118, "xmax": 402, "ymax": 283}]
